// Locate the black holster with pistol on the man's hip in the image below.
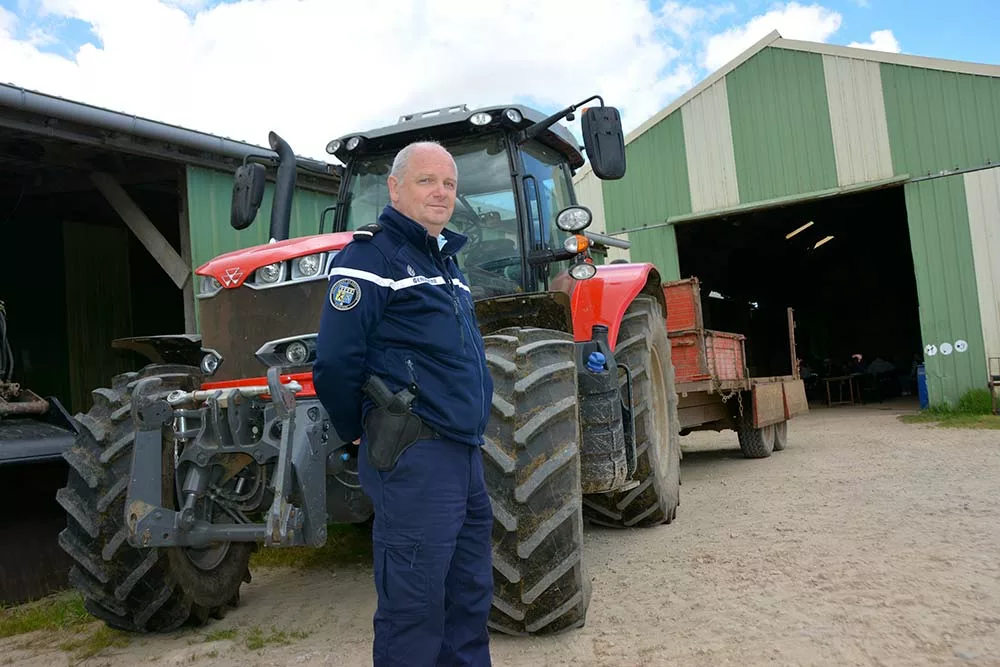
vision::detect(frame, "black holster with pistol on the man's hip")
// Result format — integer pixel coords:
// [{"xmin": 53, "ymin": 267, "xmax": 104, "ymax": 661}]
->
[{"xmin": 363, "ymin": 375, "xmax": 435, "ymax": 472}]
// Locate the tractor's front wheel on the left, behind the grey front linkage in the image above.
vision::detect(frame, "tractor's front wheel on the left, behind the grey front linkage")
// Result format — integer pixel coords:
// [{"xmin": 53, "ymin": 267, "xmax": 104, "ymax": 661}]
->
[{"xmin": 56, "ymin": 366, "xmax": 256, "ymax": 632}]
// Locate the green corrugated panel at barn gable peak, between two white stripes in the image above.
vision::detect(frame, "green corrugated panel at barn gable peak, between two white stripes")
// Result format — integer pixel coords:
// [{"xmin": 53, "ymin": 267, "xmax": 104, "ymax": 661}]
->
[{"xmin": 726, "ymin": 49, "xmax": 837, "ymax": 203}]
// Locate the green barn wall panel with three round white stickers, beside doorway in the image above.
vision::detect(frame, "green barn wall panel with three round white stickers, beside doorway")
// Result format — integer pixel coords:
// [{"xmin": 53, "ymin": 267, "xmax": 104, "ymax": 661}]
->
[{"xmin": 905, "ymin": 175, "xmax": 986, "ymax": 405}]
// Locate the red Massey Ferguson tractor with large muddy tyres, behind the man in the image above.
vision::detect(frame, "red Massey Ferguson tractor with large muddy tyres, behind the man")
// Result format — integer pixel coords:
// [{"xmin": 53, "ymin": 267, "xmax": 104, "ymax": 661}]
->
[{"xmin": 59, "ymin": 96, "xmax": 680, "ymax": 634}]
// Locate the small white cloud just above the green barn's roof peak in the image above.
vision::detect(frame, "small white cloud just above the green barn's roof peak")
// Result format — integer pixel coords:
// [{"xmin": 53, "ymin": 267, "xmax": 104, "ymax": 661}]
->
[{"xmin": 702, "ymin": 2, "xmax": 842, "ymax": 70}]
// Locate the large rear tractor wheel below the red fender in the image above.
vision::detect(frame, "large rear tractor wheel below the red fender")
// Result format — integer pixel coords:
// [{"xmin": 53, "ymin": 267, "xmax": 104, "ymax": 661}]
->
[{"xmin": 584, "ymin": 294, "xmax": 681, "ymax": 528}]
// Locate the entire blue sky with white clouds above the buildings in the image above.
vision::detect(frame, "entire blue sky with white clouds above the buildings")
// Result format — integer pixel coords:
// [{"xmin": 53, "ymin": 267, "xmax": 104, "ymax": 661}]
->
[{"xmin": 0, "ymin": 0, "xmax": 1000, "ymax": 159}]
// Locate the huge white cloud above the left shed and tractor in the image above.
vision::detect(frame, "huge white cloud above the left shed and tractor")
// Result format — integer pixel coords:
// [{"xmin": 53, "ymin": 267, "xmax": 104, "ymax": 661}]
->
[{"xmin": 0, "ymin": 0, "xmax": 695, "ymax": 159}]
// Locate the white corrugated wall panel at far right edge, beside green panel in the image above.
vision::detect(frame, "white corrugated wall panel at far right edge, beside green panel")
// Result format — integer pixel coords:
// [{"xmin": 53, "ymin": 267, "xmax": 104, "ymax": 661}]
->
[{"xmin": 965, "ymin": 168, "xmax": 1000, "ymax": 366}]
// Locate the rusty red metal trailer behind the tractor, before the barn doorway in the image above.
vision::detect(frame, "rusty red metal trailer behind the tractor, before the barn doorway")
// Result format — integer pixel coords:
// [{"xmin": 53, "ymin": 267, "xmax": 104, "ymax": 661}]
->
[{"xmin": 663, "ymin": 278, "xmax": 809, "ymax": 458}]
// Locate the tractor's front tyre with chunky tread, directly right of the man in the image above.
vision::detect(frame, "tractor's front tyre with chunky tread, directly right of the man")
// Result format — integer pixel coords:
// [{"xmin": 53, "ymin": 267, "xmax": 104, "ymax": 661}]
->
[{"xmin": 483, "ymin": 328, "xmax": 590, "ymax": 635}]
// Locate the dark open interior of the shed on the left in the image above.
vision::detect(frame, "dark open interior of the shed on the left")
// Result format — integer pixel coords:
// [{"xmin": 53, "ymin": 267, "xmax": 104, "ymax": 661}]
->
[{"xmin": 0, "ymin": 128, "xmax": 184, "ymax": 604}]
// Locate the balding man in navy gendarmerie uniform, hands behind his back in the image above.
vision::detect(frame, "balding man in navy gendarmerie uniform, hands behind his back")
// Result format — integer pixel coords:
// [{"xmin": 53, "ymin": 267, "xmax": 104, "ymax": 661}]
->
[{"xmin": 313, "ymin": 142, "xmax": 493, "ymax": 666}]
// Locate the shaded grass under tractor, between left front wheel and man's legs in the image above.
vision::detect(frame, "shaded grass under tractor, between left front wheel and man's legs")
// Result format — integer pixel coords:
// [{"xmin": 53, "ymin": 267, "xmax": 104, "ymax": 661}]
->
[{"xmin": 250, "ymin": 523, "xmax": 372, "ymax": 568}]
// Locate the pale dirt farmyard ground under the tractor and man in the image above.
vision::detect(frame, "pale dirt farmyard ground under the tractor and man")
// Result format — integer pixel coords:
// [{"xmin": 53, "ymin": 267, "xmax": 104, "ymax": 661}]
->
[{"xmin": 0, "ymin": 406, "xmax": 1000, "ymax": 667}]
